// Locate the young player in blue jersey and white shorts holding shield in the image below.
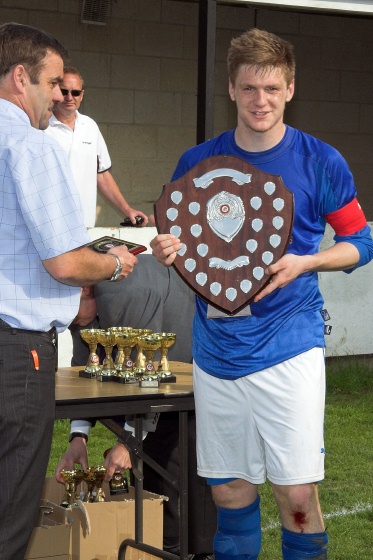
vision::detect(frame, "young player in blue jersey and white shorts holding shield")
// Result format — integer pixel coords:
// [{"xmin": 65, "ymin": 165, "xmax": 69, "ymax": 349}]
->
[{"xmin": 151, "ymin": 29, "xmax": 373, "ymax": 560}]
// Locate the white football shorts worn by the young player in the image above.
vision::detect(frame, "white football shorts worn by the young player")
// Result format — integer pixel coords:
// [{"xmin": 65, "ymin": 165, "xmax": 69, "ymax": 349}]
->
[{"xmin": 193, "ymin": 348, "xmax": 325, "ymax": 485}]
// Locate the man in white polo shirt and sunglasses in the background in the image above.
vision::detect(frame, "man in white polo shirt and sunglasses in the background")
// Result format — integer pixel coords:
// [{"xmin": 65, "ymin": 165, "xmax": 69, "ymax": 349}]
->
[{"xmin": 46, "ymin": 67, "xmax": 148, "ymax": 227}]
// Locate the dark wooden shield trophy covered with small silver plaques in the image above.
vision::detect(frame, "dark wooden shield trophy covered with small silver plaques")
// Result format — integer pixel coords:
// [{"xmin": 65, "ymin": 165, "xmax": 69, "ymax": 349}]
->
[{"xmin": 154, "ymin": 155, "xmax": 294, "ymax": 315}]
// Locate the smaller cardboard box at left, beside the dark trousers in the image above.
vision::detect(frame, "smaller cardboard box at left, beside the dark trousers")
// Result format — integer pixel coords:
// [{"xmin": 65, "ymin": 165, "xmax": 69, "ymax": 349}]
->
[{"xmin": 25, "ymin": 500, "xmax": 72, "ymax": 560}]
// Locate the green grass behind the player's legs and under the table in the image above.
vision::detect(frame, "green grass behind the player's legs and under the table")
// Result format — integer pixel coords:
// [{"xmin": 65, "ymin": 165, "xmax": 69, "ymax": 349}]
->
[{"xmin": 48, "ymin": 357, "xmax": 373, "ymax": 560}]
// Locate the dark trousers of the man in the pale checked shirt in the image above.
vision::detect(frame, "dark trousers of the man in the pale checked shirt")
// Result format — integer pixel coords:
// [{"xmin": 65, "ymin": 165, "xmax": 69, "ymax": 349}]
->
[{"xmin": 0, "ymin": 325, "xmax": 56, "ymax": 560}]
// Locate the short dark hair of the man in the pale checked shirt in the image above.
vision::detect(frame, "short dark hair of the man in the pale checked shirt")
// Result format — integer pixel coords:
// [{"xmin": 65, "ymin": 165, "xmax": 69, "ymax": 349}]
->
[{"xmin": 0, "ymin": 23, "xmax": 68, "ymax": 84}]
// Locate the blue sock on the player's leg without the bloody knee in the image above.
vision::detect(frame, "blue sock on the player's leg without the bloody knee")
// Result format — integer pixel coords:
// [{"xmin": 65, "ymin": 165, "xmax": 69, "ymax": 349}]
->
[{"xmin": 214, "ymin": 496, "xmax": 262, "ymax": 560}]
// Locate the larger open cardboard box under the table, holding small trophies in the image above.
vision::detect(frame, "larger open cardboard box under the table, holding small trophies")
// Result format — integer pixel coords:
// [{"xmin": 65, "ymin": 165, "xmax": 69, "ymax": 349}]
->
[{"xmin": 43, "ymin": 477, "xmax": 164, "ymax": 560}]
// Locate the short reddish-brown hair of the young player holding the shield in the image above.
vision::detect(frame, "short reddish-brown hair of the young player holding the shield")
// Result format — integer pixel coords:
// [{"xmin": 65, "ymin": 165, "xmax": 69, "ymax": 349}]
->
[{"xmin": 227, "ymin": 28, "xmax": 295, "ymax": 85}]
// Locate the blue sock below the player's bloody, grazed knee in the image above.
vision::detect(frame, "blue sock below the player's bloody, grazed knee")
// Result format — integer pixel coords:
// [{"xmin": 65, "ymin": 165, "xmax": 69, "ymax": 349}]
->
[{"xmin": 282, "ymin": 528, "xmax": 328, "ymax": 560}]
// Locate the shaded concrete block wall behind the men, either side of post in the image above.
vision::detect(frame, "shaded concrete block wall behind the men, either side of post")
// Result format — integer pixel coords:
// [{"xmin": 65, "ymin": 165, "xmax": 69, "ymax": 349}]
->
[{"xmin": 0, "ymin": 0, "xmax": 373, "ymax": 226}]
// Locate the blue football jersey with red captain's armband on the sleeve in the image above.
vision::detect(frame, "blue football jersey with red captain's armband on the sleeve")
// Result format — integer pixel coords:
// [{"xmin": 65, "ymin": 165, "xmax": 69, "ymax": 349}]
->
[{"xmin": 172, "ymin": 126, "xmax": 373, "ymax": 379}]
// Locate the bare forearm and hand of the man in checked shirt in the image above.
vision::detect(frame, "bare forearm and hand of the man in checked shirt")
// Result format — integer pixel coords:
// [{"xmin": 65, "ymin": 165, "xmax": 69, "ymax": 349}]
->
[{"xmin": 43, "ymin": 245, "xmax": 137, "ymax": 286}]
